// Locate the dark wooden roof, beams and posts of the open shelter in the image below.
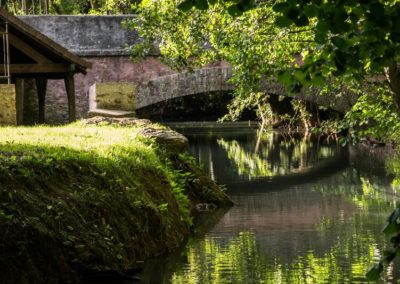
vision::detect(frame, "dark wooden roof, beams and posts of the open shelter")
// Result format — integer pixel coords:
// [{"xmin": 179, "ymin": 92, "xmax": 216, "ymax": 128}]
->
[{"xmin": 0, "ymin": 9, "xmax": 91, "ymax": 124}]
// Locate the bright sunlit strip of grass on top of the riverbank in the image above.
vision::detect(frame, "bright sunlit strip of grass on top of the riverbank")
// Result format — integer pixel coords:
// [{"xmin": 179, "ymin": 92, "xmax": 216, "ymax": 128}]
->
[{"xmin": 0, "ymin": 122, "xmax": 162, "ymax": 164}]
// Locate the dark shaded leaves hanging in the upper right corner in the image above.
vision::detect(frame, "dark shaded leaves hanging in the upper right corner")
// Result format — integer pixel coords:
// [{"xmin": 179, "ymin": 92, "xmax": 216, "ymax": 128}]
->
[{"xmin": 273, "ymin": 0, "xmax": 400, "ymax": 83}]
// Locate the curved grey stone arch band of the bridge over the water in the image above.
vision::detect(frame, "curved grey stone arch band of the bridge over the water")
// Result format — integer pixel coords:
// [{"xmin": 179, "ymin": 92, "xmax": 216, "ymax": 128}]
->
[{"xmin": 135, "ymin": 67, "xmax": 354, "ymax": 113}]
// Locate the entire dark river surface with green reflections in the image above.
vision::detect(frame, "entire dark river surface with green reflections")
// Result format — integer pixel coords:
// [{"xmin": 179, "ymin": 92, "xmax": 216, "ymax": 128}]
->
[{"xmin": 143, "ymin": 125, "xmax": 399, "ymax": 283}]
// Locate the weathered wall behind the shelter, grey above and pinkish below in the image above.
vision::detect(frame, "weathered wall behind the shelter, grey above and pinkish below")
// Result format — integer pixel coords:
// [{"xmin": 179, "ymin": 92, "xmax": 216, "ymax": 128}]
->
[{"xmin": 19, "ymin": 16, "xmax": 169, "ymax": 123}]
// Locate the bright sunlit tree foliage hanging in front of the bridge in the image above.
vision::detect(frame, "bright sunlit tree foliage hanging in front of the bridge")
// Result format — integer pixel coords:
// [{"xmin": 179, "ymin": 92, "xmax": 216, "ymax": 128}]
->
[{"xmin": 130, "ymin": 0, "xmax": 313, "ymax": 118}]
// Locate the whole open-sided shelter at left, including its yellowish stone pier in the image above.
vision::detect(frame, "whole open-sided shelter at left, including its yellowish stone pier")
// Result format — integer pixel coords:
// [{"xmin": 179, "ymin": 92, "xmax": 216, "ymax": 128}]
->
[{"xmin": 0, "ymin": 9, "xmax": 91, "ymax": 124}]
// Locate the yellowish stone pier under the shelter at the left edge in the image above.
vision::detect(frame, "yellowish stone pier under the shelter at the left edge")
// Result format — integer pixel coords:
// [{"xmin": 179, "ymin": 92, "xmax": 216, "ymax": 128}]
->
[{"xmin": 0, "ymin": 84, "xmax": 17, "ymax": 125}]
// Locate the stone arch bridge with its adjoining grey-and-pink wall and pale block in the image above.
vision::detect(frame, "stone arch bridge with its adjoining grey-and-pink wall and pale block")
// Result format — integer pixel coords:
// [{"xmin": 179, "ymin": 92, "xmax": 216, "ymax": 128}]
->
[{"xmin": 20, "ymin": 15, "xmax": 354, "ymax": 123}]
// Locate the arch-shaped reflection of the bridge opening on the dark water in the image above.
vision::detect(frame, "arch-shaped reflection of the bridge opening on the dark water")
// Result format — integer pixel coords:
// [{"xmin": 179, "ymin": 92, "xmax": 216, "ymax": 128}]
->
[{"xmin": 186, "ymin": 129, "xmax": 348, "ymax": 183}]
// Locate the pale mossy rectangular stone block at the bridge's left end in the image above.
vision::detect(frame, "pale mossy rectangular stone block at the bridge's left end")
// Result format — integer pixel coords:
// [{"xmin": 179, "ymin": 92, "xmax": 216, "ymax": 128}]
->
[{"xmin": 89, "ymin": 83, "xmax": 136, "ymax": 111}]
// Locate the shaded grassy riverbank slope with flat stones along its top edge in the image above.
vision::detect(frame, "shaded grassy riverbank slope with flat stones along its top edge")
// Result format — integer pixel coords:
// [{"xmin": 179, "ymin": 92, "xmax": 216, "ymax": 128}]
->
[{"xmin": 0, "ymin": 118, "xmax": 232, "ymax": 283}]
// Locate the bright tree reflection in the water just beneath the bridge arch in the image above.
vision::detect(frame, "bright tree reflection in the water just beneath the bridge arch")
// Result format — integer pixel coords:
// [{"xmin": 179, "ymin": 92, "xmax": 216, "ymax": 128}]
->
[{"xmin": 217, "ymin": 132, "xmax": 339, "ymax": 179}]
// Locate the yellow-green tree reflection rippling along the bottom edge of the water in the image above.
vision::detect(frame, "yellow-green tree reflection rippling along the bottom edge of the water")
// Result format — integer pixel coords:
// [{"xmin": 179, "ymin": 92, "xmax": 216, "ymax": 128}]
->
[{"xmin": 171, "ymin": 229, "xmax": 392, "ymax": 284}]
